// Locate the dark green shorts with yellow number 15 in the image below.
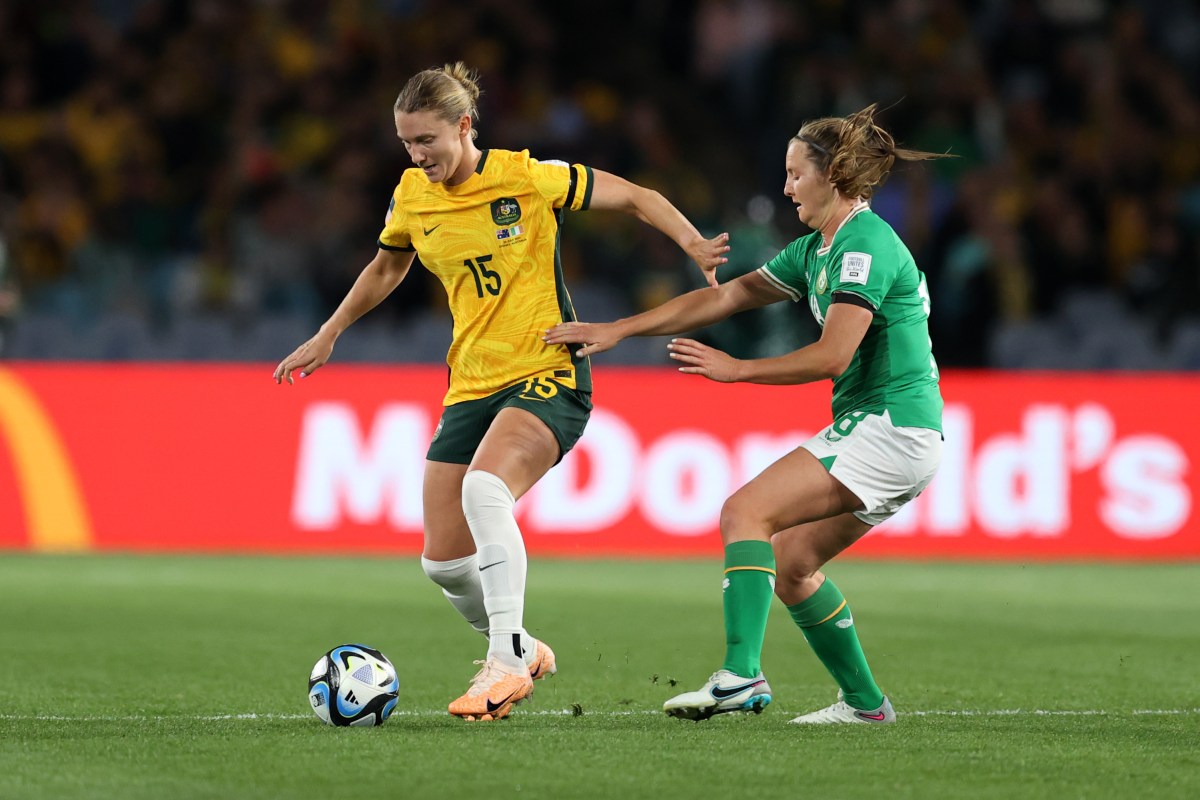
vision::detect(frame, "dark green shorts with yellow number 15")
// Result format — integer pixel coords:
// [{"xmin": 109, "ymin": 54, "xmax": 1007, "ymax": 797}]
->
[{"xmin": 425, "ymin": 378, "xmax": 592, "ymax": 464}]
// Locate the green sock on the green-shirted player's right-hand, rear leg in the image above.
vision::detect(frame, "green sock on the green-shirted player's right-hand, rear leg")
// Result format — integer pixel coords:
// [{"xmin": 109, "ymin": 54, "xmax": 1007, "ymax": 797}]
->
[{"xmin": 792, "ymin": 578, "xmax": 883, "ymax": 711}]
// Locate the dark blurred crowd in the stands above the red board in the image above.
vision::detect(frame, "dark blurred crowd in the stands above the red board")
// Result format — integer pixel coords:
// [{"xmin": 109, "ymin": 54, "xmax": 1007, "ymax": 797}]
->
[{"xmin": 0, "ymin": 0, "xmax": 1200, "ymax": 368}]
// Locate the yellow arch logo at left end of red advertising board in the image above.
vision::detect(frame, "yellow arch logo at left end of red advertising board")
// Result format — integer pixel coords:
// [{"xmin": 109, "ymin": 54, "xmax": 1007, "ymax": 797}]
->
[{"xmin": 0, "ymin": 368, "xmax": 92, "ymax": 553}]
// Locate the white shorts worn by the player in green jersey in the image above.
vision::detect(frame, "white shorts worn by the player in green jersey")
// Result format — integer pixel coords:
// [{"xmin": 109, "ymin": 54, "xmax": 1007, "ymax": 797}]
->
[{"xmin": 800, "ymin": 411, "xmax": 942, "ymax": 525}]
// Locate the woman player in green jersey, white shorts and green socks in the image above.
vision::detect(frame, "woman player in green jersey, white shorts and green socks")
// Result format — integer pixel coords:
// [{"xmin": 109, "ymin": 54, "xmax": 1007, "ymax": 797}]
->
[{"xmin": 544, "ymin": 106, "xmax": 942, "ymax": 723}]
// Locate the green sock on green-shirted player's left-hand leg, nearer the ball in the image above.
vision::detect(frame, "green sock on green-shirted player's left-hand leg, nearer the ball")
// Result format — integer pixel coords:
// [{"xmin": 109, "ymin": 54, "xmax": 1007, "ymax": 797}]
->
[{"xmin": 721, "ymin": 540, "xmax": 777, "ymax": 681}]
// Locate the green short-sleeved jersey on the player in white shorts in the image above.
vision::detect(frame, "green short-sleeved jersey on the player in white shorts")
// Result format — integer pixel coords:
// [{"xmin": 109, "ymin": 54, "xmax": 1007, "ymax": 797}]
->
[{"xmin": 758, "ymin": 203, "xmax": 942, "ymax": 432}]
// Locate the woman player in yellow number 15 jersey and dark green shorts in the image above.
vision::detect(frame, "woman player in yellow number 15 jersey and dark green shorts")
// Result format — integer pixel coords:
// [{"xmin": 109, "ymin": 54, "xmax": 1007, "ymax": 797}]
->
[{"xmin": 275, "ymin": 62, "xmax": 728, "ymax": 721}]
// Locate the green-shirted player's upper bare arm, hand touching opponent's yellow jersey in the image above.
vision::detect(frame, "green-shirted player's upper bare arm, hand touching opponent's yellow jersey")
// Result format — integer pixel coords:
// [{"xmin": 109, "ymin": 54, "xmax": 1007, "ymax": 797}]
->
[{"xmin": 541, "ymin": 271, "xmax": 787, "ymax": 357}]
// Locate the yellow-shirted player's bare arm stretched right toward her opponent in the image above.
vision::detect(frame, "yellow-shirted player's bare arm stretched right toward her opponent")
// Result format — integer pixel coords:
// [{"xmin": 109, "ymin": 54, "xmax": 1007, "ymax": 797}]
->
[{"xmin": 588, "ymin": 169, "xmax": 730, "ymax": 287}]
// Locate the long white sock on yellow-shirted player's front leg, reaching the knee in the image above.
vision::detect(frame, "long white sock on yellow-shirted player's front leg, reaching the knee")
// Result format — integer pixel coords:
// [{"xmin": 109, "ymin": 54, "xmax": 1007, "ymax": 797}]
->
[{"xmin": 460, "ymin": 470, "xmax": 533, "ymax": 667}]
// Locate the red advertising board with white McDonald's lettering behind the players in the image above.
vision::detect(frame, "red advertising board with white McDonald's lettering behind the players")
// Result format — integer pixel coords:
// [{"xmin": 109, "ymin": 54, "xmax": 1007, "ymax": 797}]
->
[{"xmin": 0, "ymin": 365, "xmax": 1200, "ymax": 559}]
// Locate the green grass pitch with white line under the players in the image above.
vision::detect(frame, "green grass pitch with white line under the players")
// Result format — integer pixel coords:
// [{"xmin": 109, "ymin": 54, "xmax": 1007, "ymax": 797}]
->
[{"xmin": 0, "ymin": 553, "xmax": 1200, "ymax": 800}]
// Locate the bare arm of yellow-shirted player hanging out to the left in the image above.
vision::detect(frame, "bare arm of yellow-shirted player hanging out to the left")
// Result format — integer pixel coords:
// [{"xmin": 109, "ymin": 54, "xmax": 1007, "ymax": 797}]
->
[{"xmin": 274, "ymin": 249, "xmax": 416, "ymax": 384}]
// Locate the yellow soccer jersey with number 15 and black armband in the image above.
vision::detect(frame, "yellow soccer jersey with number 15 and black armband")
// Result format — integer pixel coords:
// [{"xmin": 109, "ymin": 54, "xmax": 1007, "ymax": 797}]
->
[{"xmin": 379, "ymin": 150, "xmax": 593, "ymax": 405}]
